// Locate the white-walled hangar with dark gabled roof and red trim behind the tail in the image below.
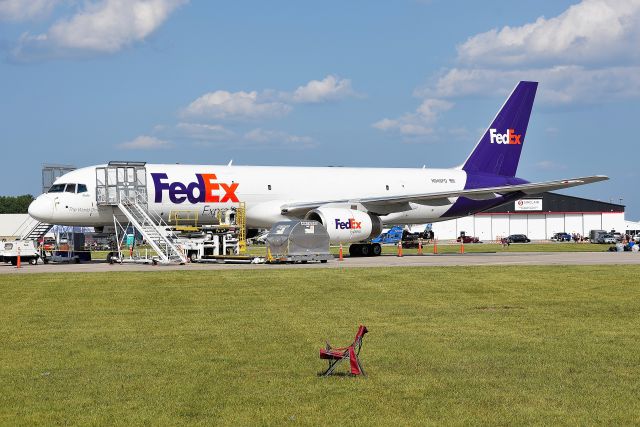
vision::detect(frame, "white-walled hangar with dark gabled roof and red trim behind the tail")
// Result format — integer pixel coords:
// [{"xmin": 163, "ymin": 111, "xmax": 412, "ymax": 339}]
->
[{"xmin": 424, "ymin": 193, "xmax": 630, "ymax": 242}]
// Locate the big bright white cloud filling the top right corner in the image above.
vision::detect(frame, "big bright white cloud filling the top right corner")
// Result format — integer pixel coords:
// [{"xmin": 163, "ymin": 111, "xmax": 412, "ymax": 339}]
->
[{"xmin": 458, "ymin": 0, "xmax": 640, "ymax": 65}]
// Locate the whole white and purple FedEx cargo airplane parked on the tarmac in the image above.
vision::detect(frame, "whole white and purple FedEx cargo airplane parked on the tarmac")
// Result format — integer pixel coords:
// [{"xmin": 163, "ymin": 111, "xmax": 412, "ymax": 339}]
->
[{"xmin": 29, "ymin": 81, "xmax": 608, "ymax": 252}]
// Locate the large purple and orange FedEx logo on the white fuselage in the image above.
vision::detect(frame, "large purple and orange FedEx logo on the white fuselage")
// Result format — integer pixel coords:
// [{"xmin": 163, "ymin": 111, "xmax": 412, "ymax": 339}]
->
[{"xmin": 151, "ymin": 173, "xmax": 240, "ymax": 205}]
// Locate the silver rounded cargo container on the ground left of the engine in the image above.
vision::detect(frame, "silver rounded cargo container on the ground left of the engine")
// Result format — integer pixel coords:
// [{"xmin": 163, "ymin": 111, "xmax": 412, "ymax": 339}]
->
[{"xmin": 265, "ymin": 221, "xmax": 333, "ymax": 262}]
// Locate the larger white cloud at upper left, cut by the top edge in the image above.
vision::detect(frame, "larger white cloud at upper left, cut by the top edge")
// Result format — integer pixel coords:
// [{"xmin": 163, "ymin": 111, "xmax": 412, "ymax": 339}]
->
[{"xmin": 13, "ymin": 0, "xmax": 188, "ymax": 59}]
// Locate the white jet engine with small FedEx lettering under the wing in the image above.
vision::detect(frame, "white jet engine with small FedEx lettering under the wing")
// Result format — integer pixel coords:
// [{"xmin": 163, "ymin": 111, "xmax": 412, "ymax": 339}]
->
[{"xmin": 305, "ymin": 208, "xmax": 382, "ymax": 243}]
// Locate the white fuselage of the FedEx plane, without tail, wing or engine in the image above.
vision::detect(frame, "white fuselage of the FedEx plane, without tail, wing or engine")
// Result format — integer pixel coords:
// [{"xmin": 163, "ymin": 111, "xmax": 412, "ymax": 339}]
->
[{"xmin": 29, "ymin": 164, "xmax": 467, "ymax": 228}]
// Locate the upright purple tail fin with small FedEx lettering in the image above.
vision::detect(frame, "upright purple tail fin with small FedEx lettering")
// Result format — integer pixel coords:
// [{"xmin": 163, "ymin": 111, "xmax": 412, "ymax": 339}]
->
[{"xmin": 462, "ymin": 82, "xmax": 538, "ymax": 176}]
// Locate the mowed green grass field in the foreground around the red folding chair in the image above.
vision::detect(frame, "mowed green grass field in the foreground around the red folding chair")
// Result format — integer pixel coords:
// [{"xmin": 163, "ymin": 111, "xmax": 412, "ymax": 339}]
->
[{"xmin": 0, "ymin": 266, "xmax": 640, "ymax": 425}]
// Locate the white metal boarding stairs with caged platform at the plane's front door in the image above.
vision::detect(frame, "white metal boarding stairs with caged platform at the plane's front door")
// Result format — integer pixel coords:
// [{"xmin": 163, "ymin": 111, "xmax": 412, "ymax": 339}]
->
[{"xmin": 96, "ymin": 162, "xmax": 187, "ymax": 264}]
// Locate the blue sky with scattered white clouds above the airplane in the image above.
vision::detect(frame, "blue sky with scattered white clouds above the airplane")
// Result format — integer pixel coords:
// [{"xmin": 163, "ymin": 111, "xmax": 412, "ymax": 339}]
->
[{"xmin": 0, "ymin": 0, "xmax": 640, "ymax": 219}]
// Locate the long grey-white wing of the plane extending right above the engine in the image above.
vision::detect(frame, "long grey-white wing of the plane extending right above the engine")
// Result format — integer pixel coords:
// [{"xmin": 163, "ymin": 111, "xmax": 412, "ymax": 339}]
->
[{"xmin": 281, "ymin": 175, "xmax": 609, "ymax": 215}]
